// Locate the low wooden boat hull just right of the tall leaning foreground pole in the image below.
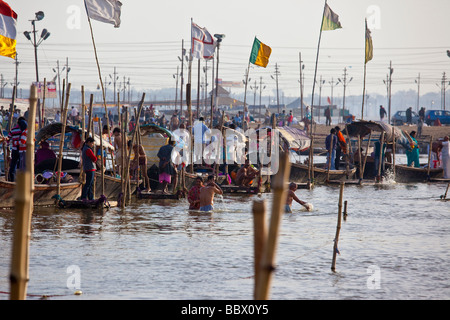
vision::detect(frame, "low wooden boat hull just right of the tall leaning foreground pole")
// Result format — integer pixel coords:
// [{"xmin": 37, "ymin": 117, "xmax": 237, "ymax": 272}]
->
[{"xmin": 289, "ymin": 163, "xmax": 356, "ymax": 184}]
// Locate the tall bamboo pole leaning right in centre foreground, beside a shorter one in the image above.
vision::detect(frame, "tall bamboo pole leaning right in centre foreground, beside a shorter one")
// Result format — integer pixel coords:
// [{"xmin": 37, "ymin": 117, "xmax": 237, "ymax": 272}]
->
[{"xmin": 255, "ymin": 153, "xmax": 291, "ymax": 300}]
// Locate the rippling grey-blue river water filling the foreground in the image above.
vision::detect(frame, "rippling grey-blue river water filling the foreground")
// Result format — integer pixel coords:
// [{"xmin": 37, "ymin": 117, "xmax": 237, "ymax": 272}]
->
[{"xmin": 0, "ymin": 180, "xmax": 450, "ymax": 299}]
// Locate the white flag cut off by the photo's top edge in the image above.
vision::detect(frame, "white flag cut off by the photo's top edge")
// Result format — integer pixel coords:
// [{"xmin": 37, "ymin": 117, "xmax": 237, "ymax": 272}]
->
[{"xmin": 84, "ymin": 0, "xmax": 122, "ymax": 28}]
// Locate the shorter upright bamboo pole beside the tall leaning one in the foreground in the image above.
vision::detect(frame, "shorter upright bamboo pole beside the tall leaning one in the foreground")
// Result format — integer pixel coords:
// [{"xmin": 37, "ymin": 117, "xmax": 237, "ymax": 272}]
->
[{"xmin": 253, "ymin": 200, "xmax": 267, "ymax": 299}]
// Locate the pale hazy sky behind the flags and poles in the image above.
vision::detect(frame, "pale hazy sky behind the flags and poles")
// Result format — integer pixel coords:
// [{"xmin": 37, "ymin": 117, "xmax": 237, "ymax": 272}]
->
[{"xmin": 0, "ymin": 0, "xmax": 450, "ymax": 101}]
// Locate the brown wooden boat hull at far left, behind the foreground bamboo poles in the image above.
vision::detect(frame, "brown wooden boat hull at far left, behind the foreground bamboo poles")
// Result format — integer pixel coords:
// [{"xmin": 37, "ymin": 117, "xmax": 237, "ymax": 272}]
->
[{"xmin": 0, "ymin": 177, "xmax": 82, "ymax": 209}]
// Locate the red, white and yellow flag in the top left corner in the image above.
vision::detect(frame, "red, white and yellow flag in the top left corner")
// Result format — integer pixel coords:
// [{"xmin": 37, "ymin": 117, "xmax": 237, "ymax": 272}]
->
[{"xmin": 0, "ymin": 0, "xmax": 17, "ymax": 59}]
